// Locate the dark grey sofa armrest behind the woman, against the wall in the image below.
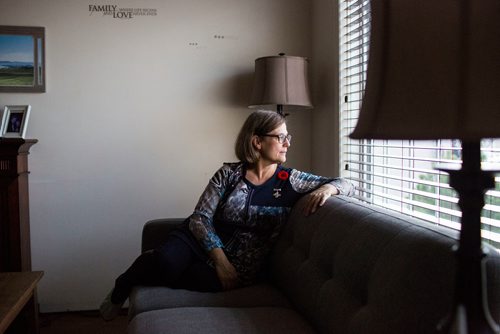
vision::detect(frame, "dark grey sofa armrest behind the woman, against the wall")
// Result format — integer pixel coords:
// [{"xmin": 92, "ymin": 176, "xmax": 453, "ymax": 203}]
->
[{"xmin": 141, "ymin": 218, "xmax": 185, "ymax": 253}]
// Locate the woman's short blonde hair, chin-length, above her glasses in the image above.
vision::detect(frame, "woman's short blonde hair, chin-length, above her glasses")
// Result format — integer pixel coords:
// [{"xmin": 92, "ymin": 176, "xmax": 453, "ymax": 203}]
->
[{"xmin": 234, "ymin": 110, "xmax": 286, "ymax": 164}]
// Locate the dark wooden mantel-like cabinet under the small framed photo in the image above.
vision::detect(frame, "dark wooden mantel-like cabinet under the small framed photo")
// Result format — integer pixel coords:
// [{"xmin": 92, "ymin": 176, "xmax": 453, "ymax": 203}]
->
[{"xmin": 0, "ymin": 138, "xmax": 38, "ymax": 272}]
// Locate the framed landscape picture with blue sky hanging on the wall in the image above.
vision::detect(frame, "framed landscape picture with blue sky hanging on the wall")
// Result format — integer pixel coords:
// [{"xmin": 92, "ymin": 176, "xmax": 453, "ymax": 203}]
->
[{"xmin": 0, "ymin": 25, "xmax": 46, "ymax": 93}]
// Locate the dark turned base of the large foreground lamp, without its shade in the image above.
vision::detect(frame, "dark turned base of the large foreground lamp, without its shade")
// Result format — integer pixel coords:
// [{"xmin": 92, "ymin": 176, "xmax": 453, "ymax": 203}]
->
[{"xmin": 438, "ymin": 141, "xmax": 500, "ymax": 334}]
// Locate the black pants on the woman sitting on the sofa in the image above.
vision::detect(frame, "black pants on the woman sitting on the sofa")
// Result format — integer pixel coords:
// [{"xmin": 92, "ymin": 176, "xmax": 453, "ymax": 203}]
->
[{"xmin": 111, "ymin": 235, "xmax": 222, "ymax": 304}]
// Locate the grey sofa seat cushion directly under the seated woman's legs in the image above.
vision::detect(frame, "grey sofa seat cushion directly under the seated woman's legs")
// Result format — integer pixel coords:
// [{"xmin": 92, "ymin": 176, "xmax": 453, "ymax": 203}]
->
[{"xmin": 129, "ymin": 284, "xmax": 290, "ymax": 319}]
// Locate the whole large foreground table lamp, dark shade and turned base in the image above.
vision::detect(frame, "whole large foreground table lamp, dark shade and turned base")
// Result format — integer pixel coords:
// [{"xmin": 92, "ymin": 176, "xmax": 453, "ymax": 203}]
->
[{"xmin": 350, "ymin": 0, "xmax": 500, "ymax": 334}]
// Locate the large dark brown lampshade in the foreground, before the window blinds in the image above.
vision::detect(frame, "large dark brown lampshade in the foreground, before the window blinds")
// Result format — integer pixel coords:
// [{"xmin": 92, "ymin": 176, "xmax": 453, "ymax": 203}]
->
[{"xmin": 351, "ymin": 0, "xmax": 500, "ymax": 140}]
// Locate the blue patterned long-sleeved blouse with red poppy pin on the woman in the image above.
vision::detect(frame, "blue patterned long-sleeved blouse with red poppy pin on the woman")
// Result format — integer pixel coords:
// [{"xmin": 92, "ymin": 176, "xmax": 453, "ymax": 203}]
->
[{"xmin": 186, "ymin": 163, "xmax": 354, "ymax": 285}]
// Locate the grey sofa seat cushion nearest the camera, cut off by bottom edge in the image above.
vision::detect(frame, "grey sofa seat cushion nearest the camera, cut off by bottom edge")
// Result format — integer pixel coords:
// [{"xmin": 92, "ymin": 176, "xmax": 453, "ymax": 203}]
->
[{"xmin": 128, "ymin": 307, "xmax": 315, "ymax": 334}]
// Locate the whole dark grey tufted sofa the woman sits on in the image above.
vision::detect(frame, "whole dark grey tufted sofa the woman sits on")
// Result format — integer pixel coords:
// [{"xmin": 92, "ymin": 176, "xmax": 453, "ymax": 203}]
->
[{"xmin": 128, "ymin": 196, "xmax": 500, "ymax": 334}]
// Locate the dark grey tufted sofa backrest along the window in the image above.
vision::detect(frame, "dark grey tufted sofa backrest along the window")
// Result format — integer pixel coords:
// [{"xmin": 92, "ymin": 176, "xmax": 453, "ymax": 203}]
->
[{"xmin": 271, "ymin": 196, "xmax": 500, "ymax": 334}]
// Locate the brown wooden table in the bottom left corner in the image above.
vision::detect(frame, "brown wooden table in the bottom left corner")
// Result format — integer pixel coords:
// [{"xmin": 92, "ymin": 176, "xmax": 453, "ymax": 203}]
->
[{"xmin": 0, "ymin": 271, "xmax": 43, "ymax": 334}]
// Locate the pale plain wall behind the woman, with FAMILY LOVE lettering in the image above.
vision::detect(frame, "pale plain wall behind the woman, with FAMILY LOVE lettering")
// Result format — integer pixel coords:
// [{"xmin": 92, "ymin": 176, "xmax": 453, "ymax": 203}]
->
[{"xmin": 0, "ymin": 0, "xmax": 311, "ymax": 312}]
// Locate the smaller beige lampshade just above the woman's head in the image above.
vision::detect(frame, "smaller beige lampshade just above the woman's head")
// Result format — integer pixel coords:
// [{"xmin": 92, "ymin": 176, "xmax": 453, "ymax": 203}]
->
[{"xmin": 249, "ymin": 55, "xmax": 312, "ymax": 109}]
